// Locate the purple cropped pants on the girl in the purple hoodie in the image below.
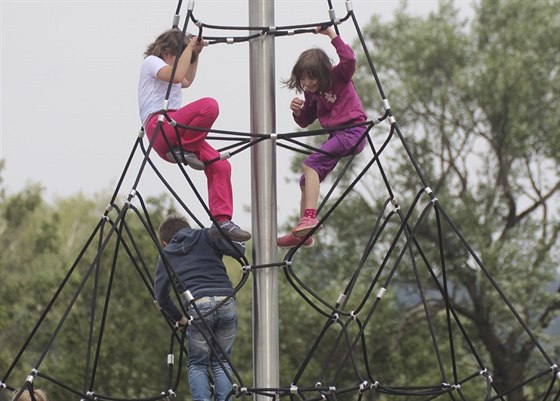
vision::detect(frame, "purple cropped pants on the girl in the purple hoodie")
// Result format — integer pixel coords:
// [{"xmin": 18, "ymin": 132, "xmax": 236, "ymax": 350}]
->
[{"xmin": 299, "ymin": 127, "xmax": 366, "ymax": 187}]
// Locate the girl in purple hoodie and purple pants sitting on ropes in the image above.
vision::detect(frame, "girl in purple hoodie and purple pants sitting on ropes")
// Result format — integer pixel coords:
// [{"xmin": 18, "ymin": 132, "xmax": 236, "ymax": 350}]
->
[{"xmin": 277, "ymin": 27, "xmax": 366, "ymax": 248}]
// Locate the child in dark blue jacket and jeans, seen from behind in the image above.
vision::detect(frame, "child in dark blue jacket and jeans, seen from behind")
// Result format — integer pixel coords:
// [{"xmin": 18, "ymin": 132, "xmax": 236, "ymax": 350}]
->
[{"xmin": 154, "ymin": 217, "xmax": 245, "ymax": 401}]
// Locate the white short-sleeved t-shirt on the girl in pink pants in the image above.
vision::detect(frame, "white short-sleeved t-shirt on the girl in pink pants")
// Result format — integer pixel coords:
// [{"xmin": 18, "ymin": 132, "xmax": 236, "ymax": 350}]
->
[{"xmin": 138, "ymin": 56, "xmax": 182, "ymax": 125}]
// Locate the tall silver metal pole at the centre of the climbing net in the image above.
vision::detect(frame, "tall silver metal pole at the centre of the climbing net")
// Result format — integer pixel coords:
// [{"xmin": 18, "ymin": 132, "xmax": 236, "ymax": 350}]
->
[{"xmin": 249, "ymin": 0, "xmax": 280, "ymax": 401}]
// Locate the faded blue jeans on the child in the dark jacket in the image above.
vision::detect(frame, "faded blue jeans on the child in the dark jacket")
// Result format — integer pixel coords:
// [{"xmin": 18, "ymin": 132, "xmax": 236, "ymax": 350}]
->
[{"xmin": 186, "ymin": 297, "xmax": 237, "ymax": 401}]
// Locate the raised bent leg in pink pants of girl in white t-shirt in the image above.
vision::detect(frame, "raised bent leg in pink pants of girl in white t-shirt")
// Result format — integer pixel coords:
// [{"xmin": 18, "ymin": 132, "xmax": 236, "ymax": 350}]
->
[{"xmin": 167, "ymin": 97, "xmax": 219, "ymax": 156}]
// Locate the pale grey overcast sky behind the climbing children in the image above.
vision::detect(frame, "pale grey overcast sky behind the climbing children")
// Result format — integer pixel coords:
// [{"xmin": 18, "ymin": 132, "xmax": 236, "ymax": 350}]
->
[{"xmin": 0, "ymin": 0, "xmax": 473, "ymax": 229}]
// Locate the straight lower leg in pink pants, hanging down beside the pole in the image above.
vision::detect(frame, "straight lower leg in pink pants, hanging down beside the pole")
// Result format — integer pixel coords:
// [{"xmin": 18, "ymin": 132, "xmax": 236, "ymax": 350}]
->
[{"xmin": 199, "ymin": 141, "xmax": 233, "ymax": 220}]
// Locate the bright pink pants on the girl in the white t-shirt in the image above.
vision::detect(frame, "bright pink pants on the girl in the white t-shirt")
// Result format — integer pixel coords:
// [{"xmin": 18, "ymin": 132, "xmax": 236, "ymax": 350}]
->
[{"xmin": 144, "ymin": 97, "xmax": 233, "ymax": 219}]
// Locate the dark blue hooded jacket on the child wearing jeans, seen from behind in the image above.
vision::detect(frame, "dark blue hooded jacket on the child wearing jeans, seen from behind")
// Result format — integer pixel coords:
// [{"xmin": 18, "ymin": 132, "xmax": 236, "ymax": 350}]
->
[{"xmin": 154, "ymin": 228, "xmax": 245, "ymax": 321}]
